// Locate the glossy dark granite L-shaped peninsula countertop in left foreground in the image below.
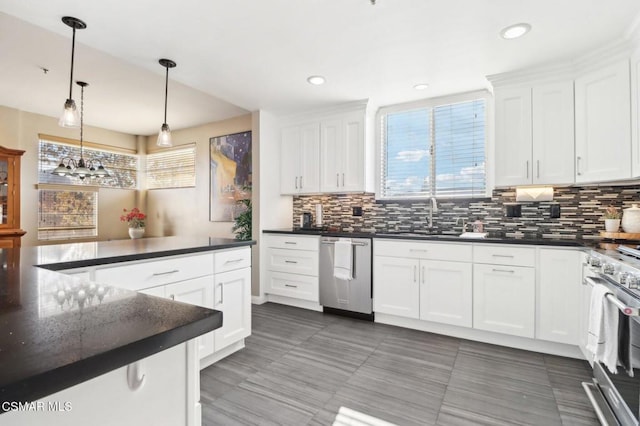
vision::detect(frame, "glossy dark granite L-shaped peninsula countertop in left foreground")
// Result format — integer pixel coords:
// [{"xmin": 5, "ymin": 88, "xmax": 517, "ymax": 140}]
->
[{"xmin": 0, "ymin": 237, "xmax": 255, "ymax": 410}]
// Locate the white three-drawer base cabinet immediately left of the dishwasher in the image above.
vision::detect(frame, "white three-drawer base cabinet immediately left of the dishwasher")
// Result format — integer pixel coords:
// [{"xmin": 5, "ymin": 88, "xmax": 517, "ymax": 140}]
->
[{"xmin": 263, "ymin": 234, "xmax": 320, "ymax": 303}]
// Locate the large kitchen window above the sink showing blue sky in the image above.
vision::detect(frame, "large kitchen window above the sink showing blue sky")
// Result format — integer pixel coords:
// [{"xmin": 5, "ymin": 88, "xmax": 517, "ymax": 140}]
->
[{"xmin": 377, "ymin": 93, "xmax": 487, "ymax": 199}]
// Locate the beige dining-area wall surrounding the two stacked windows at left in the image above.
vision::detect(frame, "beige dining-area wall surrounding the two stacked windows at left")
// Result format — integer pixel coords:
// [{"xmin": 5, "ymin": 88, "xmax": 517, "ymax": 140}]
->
[{"xmin": 0, "ymin": 106, "xmax": 137, "ymax": 246}]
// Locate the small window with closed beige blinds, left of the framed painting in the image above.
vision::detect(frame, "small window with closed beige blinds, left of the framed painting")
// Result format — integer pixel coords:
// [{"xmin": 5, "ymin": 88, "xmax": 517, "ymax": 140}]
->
[{"xmin": 147, "ymin": 145, "xmax": 196, "ymax": 189}]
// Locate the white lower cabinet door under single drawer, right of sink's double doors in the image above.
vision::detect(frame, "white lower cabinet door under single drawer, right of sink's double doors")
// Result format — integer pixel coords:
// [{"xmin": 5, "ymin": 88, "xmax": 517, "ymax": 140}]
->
[{"xmin": 473, "ymin": 264, "xmax": 536, "ymax": 338}]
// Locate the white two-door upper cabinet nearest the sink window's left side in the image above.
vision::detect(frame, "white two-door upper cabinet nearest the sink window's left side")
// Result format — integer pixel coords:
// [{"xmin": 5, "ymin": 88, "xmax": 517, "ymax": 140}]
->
[{"xmin": 320, "ymin": 112, "xmax": 365, "ymax": 192}]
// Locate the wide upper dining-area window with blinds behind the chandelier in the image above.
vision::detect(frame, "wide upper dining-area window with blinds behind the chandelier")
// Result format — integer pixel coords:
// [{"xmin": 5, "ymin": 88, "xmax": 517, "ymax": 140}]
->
[{"xmin": 38, "ymin": 135, "xmax": 138, "ymax": 189}]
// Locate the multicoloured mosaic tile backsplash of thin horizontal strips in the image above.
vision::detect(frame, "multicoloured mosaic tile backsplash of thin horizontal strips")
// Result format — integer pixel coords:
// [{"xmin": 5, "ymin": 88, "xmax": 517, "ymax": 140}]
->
[{"xmin": 293, "ymin": 185, "xmax": 640, "ymax": 239}]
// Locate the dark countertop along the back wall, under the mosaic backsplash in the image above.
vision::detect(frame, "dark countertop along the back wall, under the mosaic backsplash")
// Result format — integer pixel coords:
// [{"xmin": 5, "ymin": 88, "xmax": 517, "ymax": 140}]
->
[{"xmin": 262, "ymin": 228, "xmax": 600, "ymax": 248}]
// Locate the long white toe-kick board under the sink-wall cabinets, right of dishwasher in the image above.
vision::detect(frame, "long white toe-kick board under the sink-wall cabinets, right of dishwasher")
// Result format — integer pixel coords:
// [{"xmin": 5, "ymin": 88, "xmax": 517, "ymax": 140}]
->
[{"xmin": 375, "ymin": 312, "xmax": 585, "ymax": 359}]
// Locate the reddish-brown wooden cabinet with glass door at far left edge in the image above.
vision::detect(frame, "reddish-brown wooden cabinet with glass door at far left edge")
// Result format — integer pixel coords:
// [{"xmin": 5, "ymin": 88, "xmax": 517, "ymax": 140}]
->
[{"xmin": 0, "ymin": 146, "xmax": 26, "ymax": 248}]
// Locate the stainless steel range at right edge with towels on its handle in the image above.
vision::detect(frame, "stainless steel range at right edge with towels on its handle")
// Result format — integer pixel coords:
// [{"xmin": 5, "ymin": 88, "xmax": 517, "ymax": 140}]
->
[{"xmin": 582, "ymin": 246, "xmax": 640, "ymax": 426}]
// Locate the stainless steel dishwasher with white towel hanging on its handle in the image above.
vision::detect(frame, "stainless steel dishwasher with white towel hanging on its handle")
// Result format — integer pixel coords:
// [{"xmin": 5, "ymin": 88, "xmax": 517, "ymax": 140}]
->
[{"xmin": 320, "ymin": 237, "xmax": 373, "ymax": 320}]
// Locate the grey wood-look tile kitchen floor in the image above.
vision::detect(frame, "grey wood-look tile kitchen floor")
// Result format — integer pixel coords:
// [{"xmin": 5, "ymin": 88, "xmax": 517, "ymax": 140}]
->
[{"xmin": 201, "ymin": 303, "xmax": 598, "ymax": 426}]
